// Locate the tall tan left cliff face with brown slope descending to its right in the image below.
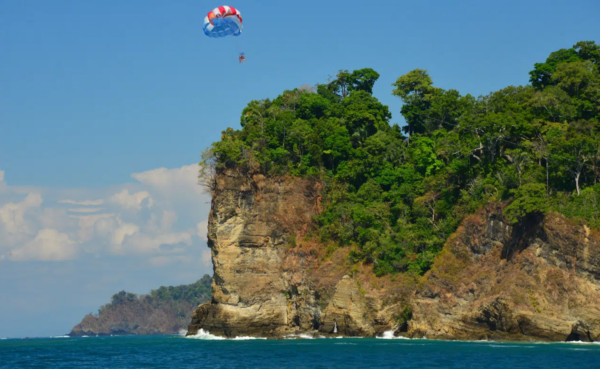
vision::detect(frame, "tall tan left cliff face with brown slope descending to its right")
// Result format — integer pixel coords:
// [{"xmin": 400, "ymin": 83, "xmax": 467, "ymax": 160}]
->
[{"xmin": 188, "ymin": 171, "xmax": 390, "ymax": 337}]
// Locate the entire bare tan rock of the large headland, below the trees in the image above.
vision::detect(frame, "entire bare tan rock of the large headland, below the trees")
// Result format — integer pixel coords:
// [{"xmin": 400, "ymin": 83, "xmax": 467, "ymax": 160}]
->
[{"xmin": 188, "ymin": 171, "xmax": 600, "ymax": 341}]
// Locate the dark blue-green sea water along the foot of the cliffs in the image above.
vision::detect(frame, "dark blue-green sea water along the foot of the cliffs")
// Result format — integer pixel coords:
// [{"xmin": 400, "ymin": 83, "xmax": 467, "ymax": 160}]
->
[{"xmin": 0, "ymin": 337, "xmax": 600, "ymax": 369}]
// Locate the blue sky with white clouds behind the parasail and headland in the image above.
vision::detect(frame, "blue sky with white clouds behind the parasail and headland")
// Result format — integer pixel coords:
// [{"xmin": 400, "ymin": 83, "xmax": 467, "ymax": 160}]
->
[{"xmin": 0, "ymin": 0, "xmax": 600, "ymax": 337}]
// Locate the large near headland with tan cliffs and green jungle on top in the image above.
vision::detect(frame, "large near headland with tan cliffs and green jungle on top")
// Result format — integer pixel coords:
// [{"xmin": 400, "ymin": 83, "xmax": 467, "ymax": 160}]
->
[{"xmin": 189, "ymin": 41, "xmax": 600, "ymax": 341}]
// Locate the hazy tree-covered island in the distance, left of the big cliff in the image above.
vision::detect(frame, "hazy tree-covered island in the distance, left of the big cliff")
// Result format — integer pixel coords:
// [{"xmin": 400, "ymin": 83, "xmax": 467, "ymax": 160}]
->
[{"xmin": 69, "ymin": 275, "xmax": 212, "ymax": 337}]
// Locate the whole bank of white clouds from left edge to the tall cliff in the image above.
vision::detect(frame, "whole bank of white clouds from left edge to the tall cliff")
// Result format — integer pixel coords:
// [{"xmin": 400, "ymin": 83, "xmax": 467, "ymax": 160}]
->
[{"xmin": 0, "ymin": 164, "xmax": 210, "ymax": 263}]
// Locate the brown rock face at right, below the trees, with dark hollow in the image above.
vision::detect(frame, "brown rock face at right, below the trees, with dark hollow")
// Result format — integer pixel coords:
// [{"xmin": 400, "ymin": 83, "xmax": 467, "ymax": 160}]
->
[{"xmin": 407, "ymin": 204, "xmax": 600, "ymax": 341}]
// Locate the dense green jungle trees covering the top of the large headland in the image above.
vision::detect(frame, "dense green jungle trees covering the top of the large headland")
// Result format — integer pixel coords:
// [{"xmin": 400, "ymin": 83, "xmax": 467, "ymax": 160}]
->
[{"xmin": 201, "ymin": 41, "xmax": 600, "ymax": 275}]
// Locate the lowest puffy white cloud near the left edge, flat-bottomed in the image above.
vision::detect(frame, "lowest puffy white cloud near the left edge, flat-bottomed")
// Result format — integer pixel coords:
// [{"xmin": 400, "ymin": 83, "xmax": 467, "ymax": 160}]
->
[{"xmin": 8, "ymin": 229, "xmax": 77, "ymax": 261}]
